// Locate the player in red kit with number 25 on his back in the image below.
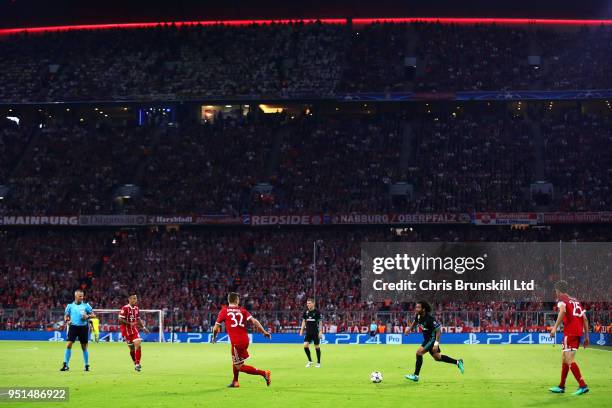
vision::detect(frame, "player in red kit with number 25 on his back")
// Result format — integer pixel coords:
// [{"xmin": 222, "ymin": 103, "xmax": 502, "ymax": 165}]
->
[{"xmin": 550, "ymin": 281, "xmax": 589, "ymax": 395}]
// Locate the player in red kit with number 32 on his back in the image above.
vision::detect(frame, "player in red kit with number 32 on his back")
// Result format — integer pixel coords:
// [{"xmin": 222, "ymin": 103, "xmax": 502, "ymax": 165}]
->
[{"xmin": 212, "ymin": 292, "xmax": 272, "ymax": 388}]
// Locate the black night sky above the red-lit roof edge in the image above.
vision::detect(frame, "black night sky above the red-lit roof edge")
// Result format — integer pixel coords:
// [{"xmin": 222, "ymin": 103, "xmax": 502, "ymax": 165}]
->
[{"xmin": 0, "ymin": 0, "xmax": 612, "ymax": 28}]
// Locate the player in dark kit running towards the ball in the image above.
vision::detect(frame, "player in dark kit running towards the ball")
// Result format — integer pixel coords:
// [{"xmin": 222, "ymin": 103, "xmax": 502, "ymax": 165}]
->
[{"xmin": 405, "ymin": 301, "xmax": 464, "ymax": 382}]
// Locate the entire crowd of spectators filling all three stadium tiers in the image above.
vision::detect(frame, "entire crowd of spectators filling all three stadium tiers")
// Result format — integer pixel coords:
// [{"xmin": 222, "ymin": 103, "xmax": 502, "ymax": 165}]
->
[{"xmin": 0, "ymin": 19, "xmax": 612, "ymax": 331}]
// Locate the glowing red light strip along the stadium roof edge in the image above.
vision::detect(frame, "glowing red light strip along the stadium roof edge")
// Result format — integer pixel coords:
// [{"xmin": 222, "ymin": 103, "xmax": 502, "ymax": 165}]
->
[{"xmin": 0, "ymin": 17, "xmax": 612, "ymax": 35}]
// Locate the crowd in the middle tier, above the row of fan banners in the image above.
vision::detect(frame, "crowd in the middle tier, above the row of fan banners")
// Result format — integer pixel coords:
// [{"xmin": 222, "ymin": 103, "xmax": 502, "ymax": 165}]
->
[{"xmin": 0, "ymin": 105, "xmax": 612, "ymax": 217}]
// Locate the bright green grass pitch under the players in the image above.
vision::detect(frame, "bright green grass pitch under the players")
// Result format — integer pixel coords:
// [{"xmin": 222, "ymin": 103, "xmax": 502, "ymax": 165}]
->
[{"xmin": 0, "ymin": 341, "xmax": 612, "ymax": 408}]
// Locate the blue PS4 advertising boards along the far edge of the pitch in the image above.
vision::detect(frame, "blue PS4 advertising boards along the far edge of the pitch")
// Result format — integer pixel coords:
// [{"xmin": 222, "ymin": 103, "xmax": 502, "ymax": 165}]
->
[{"xmin": 0, "ymin": 330, "xmax": 612, "ymax": 346}]
